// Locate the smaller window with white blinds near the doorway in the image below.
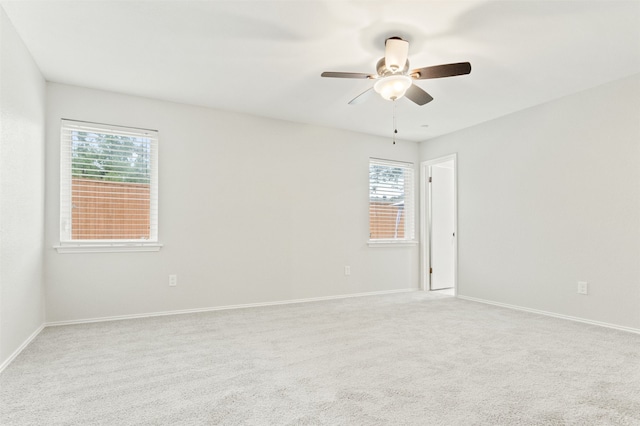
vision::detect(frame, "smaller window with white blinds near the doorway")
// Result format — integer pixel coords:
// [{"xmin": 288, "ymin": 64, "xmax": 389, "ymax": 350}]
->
[{"xmin": 369, "ymin": 158, "xmax": 415, "ymax": 242}]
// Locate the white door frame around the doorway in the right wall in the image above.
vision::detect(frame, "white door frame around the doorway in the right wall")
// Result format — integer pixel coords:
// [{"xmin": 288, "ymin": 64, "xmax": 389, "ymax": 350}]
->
[{"xmin": 420, "ymin": 153, "xmax": 458, "ymax": 295}]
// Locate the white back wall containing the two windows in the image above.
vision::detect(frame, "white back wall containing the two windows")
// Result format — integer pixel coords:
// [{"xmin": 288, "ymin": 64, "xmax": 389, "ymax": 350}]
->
[{"xmin": 45, "ymin": 84, "xmax": 418, "ymax": 321}]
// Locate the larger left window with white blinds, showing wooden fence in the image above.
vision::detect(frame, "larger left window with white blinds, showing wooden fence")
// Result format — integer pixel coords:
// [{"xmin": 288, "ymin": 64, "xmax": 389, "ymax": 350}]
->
[{"xmin": 59, "ymin": 120, "xmax": 159, "ymax": 251}]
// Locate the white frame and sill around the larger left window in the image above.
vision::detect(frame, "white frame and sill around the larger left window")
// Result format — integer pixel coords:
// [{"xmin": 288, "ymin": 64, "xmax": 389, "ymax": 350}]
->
[{"xmin": 54, "ymin": 119, "xmax": 162, "ymax": 253}]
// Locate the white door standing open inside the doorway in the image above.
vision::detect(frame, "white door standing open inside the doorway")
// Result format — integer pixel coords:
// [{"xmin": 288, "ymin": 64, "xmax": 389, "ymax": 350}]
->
[{"xmin": 430, "ymin": 160, "xmax": 456, "ymax": 290}]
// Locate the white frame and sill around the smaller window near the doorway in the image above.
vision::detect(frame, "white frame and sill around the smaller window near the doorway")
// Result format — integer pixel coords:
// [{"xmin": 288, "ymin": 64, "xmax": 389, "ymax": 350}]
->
[{"xmin": 367, "ymin": 157, "xmax": 418, "ymax": 247}]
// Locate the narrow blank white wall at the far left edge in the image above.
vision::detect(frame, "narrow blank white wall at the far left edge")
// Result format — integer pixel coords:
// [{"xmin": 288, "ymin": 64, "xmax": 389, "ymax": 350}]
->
[{"xmin": 0, "ymin": 7, "xmax": 45, "ymax": 366}]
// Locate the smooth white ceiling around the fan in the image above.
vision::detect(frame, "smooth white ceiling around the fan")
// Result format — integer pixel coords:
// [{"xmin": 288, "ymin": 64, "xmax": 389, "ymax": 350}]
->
[{"xmin": 0, "ymin": 0, "xmax": 640, "ymax": 141}]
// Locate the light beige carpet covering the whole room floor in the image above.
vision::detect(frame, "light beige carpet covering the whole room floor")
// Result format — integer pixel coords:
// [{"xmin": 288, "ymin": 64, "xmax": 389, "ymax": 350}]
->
[{"xmin": 0, "ymin": 292, "xmax": 640, "ymax": 426}]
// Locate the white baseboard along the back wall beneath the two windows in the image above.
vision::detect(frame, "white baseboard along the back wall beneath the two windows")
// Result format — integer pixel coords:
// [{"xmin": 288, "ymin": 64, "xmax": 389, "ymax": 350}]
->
[{"xmin": 45, "ymin": 288, "xmax": 418, "ymax": 327}]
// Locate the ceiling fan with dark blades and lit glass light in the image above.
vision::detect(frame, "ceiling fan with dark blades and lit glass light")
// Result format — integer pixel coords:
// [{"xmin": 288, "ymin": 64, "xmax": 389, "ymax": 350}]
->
[{"xmin": 321, "ymin": 37, "xmax": 471, "ymax": 105}]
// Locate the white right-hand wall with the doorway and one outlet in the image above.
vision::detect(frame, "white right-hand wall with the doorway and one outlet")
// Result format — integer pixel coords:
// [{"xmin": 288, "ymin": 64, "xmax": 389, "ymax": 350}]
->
[{"xmin": 420, "ymin": 75, "xmax": 640, "ymax": 329}]
